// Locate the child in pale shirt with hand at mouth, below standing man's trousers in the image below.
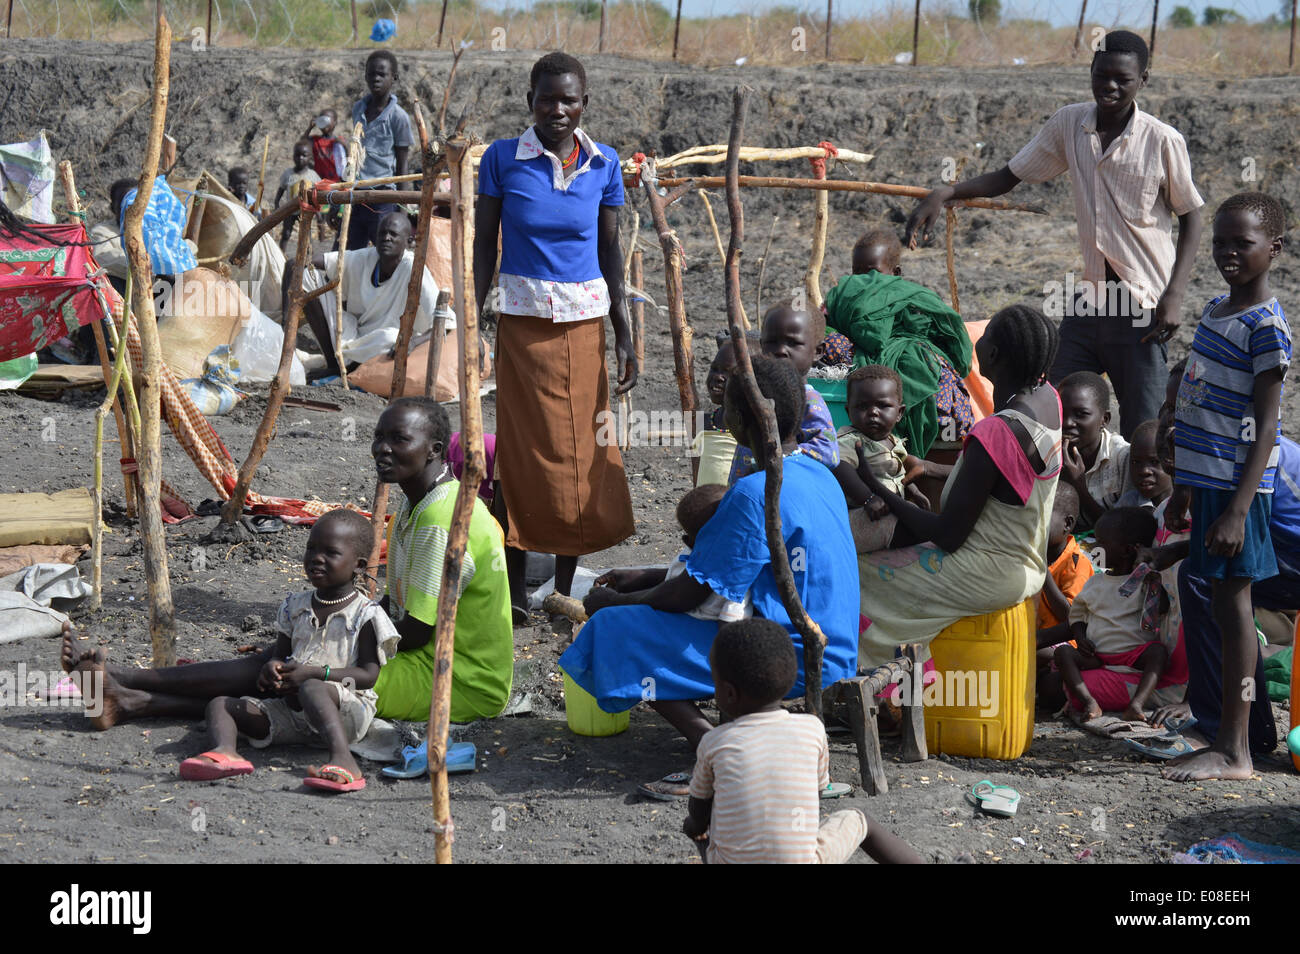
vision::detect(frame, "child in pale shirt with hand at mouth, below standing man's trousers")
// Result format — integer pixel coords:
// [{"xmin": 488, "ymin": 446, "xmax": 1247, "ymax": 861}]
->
[{"xmin": 1057, "ymin": 369, "xmax": 1132, "ymax": 530}]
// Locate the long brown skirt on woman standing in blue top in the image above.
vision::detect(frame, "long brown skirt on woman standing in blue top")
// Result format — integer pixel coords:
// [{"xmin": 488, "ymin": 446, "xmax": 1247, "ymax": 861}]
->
[{"xmin": 497, "ymin": 315, "xmax": 636, "ymax": 556}]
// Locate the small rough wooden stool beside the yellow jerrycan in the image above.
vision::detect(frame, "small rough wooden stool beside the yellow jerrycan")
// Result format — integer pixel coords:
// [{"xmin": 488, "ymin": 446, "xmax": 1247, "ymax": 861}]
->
[{"xmin": 822, "ymin": 643, "xmax": 930, "ymax": 795}]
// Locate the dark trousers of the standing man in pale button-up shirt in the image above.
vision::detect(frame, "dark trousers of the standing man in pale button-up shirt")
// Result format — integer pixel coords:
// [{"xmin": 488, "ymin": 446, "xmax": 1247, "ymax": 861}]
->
[{"xmin": 1048, "ymin": 285, "xmax": 1169, "ymax": 441}]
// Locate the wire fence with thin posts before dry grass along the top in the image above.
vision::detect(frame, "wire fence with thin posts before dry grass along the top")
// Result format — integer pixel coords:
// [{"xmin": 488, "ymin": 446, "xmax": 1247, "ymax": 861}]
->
[{"xmin": 0, "ymin": 0, "xmax": 1296, "ymax": 73}]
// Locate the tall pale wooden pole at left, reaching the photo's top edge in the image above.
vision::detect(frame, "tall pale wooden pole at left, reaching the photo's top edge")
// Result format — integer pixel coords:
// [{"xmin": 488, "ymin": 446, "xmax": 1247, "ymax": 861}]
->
[{"xmin": 118, "ymin": 3, "xmax": 176, "ymax": 667}]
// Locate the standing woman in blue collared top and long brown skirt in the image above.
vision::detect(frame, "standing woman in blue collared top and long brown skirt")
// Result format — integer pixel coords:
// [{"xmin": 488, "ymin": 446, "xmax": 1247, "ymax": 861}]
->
[{"xmin": 475, "ymin": 53, "xmax": 637, "ymax": 623}]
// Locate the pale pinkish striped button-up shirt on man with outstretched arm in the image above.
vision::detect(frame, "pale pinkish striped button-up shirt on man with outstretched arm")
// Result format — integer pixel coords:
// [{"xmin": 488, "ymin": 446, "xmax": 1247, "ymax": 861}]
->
[{"xmin": 1008, "ymin": 103, "xmax": 1205, "ymax": 308}]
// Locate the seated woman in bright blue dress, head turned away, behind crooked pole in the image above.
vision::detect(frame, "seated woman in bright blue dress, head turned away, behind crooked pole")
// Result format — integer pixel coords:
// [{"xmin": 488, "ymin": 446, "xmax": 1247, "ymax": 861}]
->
[{"xmin": 559, "ymin": 356, "xmax": 858, "ymax": 747}]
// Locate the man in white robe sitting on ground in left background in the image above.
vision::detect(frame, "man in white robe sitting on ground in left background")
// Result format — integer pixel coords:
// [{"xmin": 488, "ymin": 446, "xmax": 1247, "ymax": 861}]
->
[{"xmin": 299, "ymin": 212, "xmax": 454, "ymax": 377}]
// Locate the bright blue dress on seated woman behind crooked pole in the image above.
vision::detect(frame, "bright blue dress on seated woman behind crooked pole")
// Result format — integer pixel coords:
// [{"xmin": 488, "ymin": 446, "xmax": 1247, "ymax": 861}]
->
[{"xmin": 559, "ymin": 454, "xmax": 858, "ymax": 712}]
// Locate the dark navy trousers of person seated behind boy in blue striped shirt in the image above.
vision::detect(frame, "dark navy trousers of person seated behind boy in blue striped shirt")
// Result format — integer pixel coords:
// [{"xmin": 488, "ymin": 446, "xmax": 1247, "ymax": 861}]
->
[{"xmin": 1178, "ymin": 561, "xmax": 1300, "ymax": 753}]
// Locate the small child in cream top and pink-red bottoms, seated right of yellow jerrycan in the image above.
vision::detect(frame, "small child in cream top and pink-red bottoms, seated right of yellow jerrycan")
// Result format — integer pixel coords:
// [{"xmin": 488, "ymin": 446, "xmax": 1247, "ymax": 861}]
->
[{"xmin": 1054, "ymin": 507, "xmax": 1187, "ymax": 723}]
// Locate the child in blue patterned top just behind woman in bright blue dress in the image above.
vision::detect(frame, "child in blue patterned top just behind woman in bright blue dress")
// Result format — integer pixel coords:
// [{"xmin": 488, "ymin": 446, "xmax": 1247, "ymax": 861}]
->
[{"xmin": 727, "ymin": 304, "xmax": 840, "ymax": 485}]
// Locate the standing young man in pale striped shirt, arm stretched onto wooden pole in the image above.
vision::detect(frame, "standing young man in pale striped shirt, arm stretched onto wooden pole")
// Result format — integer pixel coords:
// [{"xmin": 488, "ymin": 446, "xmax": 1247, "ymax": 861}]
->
[{"xmin": 907, "ymin": 30, "xmax": 1204, "ymax": 441}]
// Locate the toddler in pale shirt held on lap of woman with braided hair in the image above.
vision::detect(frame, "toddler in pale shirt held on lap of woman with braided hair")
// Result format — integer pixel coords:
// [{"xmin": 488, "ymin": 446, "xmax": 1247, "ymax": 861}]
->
[{"xmin": 835, "ymin": 364, "xmax": 952, "ymax": 554}]
